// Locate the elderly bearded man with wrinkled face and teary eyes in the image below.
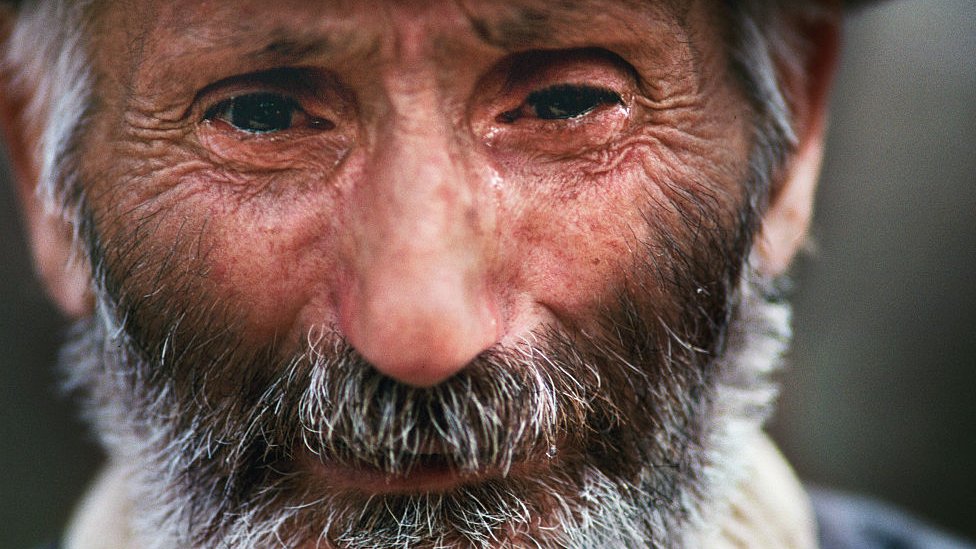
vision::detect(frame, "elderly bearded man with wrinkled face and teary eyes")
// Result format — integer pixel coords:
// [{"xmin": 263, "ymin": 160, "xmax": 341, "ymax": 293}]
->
[{"xmin": 0, "ymin": 0, "xmax": 968, "ymax": 549}]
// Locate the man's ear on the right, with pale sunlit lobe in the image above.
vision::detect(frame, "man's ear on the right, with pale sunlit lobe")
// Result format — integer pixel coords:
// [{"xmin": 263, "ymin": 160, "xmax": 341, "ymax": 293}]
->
[{"xmin": 752, "ymin": 6, "xmax": 842, "ymax": 276}]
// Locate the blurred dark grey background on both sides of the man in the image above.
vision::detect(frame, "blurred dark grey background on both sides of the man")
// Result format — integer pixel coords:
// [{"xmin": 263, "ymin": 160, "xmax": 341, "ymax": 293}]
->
[{"xmin": 0, "ymin": 0, "xmax": 976, "ymax": 549}]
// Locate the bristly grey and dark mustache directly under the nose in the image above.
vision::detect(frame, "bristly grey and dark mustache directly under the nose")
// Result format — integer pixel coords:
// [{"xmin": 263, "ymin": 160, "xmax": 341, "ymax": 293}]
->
[{"xmin": 258, "ymin": 330, "xmax": 620, "ymax": 475}]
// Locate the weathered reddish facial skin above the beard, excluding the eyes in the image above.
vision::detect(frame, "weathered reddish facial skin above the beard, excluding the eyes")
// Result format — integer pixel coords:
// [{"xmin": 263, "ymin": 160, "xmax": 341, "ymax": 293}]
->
[{"xmin": 83, "ymin": 1, "xmax": 748, "ymax": 394}]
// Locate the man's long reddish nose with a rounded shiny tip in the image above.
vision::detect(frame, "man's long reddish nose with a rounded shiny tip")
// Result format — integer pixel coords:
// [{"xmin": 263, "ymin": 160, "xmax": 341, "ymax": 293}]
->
[{"xmin": 339, "ymin": 105, "xmax": 498, "ymax": 387}]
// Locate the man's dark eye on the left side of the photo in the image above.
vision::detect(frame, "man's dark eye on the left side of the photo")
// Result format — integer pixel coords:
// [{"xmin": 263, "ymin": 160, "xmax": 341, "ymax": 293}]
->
[{"xmin": 210, "ymin": 92, "xmax": 303, "ymax": 133}]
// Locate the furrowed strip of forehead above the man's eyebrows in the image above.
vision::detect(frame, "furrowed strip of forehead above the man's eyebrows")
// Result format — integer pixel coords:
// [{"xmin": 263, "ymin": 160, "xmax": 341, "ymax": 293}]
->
[{"xmin": 96, "ymin": 0, "xmax": 696, "ymax": 49}]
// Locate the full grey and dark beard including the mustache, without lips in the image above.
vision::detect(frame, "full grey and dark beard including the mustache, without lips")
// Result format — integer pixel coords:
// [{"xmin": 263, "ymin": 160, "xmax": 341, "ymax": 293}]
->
[{"xmin": 63, "ymin": 274, "xmax": 789, "ymax": 549}]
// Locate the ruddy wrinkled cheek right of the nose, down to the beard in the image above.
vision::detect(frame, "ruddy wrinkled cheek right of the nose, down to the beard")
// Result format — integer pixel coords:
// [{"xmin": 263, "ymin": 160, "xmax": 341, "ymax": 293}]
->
[{"xmin": 503, "ymin": 130, "xmax": 745, "ymax": 324}]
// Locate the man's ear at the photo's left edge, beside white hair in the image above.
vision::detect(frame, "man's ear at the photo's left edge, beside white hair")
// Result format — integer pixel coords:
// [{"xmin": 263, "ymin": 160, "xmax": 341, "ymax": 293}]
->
[{"xmin": 0, "ymin": 5, "xmax": 94, "ymax": 318}]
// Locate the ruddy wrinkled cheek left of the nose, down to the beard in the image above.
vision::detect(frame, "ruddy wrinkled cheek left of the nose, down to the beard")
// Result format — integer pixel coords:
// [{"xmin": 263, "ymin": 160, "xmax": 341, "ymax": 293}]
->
[{"xmin": 92, "ymin": 158, "xmax": 350, "ymax": 344}]
